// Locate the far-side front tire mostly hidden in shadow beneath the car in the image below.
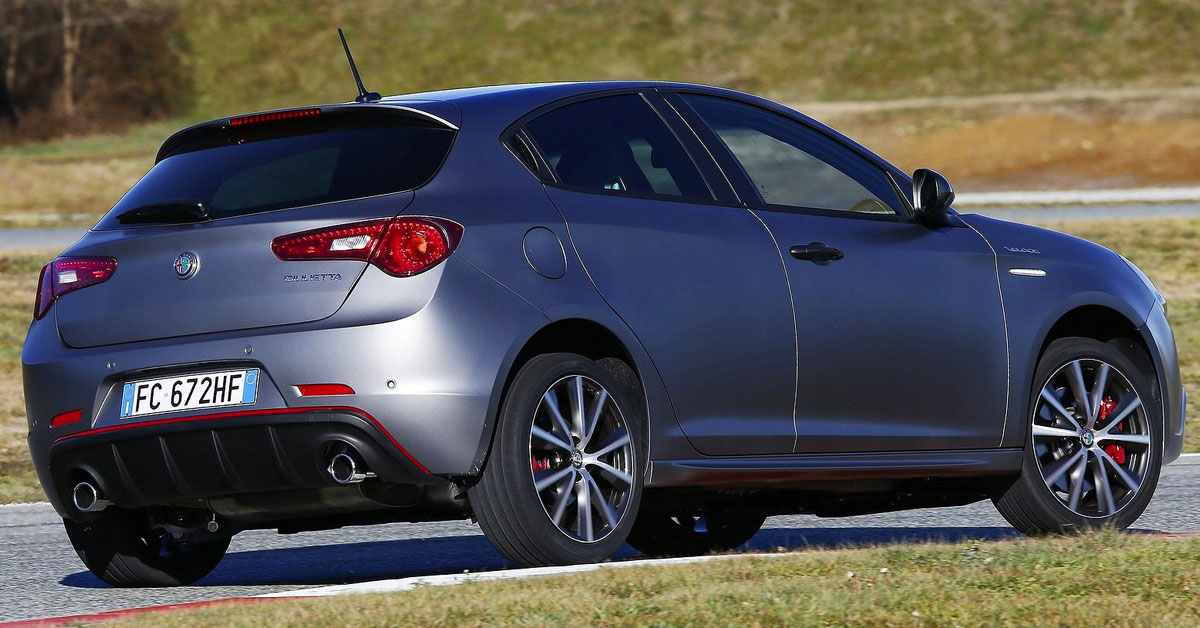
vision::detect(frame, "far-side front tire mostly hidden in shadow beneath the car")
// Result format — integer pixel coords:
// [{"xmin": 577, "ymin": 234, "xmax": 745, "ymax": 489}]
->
[{"xmin": 625, "ymin": 513, "xmax": 767, "ymax": 557}]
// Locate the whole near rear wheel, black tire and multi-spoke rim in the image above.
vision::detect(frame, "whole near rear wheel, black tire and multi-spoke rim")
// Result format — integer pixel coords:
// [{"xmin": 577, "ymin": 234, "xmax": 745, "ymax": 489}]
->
[{"xmin": 468, "ymin": 353, "xmax": 647, "ymax": 567}]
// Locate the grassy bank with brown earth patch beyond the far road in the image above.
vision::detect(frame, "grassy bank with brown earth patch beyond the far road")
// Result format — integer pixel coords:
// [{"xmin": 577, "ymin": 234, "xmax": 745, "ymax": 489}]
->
[{"xmin": 7, "ymin": 0, "xmax": 1200, "ymax": 228}]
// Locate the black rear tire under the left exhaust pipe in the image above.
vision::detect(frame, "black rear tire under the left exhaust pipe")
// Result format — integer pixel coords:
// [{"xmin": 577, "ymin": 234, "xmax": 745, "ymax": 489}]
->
[{"xmin": 62, "ymin": 508, "xmax": 229, "ymax": 587}]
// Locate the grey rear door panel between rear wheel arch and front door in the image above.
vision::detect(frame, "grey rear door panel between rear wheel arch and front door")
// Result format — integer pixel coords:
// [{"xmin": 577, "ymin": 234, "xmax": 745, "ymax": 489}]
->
[{"xmin": 548, "ymin": 187, "xmax": 796, "ymax": 455}]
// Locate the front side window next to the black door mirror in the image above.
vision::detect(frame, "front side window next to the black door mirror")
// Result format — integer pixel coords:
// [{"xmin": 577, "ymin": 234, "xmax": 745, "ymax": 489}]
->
[{"xmin": 683, "ymin": 95, "xmax": 896, "ymax": 214}]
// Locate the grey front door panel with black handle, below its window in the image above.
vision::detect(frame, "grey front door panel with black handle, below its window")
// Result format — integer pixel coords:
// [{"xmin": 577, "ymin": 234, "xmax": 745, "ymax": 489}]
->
[{"xmin": 761, "ymin": 211, "xmax": 1008, "ymax": 453}]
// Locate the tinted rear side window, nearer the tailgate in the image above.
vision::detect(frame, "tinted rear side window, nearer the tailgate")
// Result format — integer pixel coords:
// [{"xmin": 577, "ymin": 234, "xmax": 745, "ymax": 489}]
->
[{"xmin": 526, "ymin": 95, "xmax": 712, "ymax": 199}]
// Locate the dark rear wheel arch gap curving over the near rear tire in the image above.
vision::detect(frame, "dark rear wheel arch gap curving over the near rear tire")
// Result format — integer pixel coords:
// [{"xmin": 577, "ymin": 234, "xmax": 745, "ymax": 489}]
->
[{"xmin": 470, "ymin": 318, "xmax": 650, "ymax": 476}]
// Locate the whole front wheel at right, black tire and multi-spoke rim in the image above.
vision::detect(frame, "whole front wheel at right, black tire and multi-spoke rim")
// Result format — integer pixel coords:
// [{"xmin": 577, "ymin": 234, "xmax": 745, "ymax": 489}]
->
[{"xmin": 994, "ymin": 337, "xmax": 1163, "ymax": 536}]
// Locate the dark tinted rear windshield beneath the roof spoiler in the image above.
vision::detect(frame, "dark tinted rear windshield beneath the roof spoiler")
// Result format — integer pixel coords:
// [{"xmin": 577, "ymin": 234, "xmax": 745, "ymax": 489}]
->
[{"xmin": 97, "ymin": 116, "xmax": 455, "ymax": 228}]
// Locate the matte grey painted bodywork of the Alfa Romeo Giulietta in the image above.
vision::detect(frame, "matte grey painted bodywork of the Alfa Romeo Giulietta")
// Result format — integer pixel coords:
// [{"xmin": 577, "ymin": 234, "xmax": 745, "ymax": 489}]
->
[{"xmin": 22, "ymin": 83, "xmax": 1183, "ymax": 525}]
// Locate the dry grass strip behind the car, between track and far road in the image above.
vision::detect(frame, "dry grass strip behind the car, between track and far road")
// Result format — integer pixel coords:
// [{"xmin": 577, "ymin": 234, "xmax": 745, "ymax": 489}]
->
[{"xmin": 0, "ymin": 218, "xmax": 1200, "ymax": 502}]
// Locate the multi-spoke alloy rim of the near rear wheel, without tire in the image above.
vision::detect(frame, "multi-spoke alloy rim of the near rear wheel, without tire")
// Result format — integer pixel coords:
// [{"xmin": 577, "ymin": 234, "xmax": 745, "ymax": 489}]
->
[{"xmin": 529, "ymin": 375, "xmax": 634, "ymax": 543}]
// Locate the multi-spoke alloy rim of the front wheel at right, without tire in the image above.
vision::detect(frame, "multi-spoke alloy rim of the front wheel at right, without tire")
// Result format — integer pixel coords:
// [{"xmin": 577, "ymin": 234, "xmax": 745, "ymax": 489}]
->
[{"xmin": 1032, "ymin": 358, "xmax": 1153, "ymax": 518}]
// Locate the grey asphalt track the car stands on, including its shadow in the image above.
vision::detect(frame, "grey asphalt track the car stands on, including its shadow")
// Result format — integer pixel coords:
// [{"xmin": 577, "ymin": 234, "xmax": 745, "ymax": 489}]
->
[{"xmin": 0, "ymin": 455, "xmax": 1200, "ymax": 621}]
